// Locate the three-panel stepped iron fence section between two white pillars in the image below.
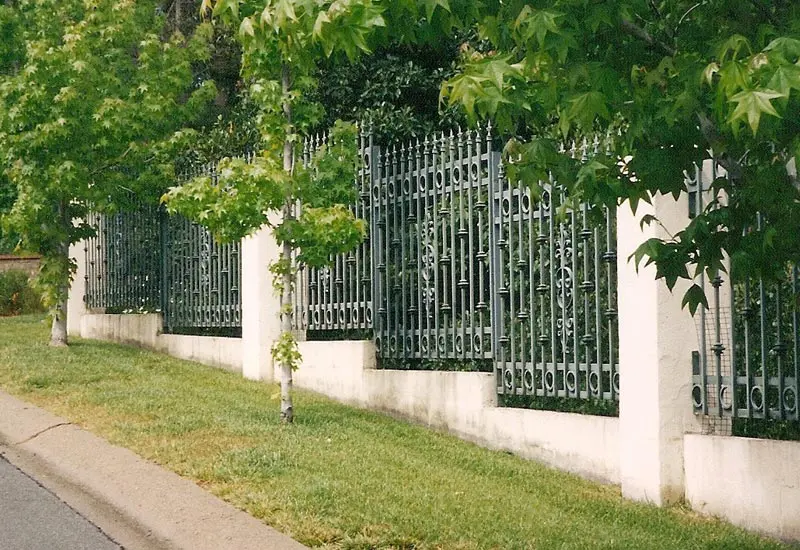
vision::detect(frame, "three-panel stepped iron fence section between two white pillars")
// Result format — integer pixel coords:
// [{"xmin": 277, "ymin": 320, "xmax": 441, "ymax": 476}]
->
[{"xmin": 295, "ymin": 128, "xmax": 619, "ymax": 401}]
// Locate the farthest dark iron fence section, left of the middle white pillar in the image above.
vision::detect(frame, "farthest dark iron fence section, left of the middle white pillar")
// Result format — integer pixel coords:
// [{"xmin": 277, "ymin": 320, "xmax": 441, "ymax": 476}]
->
[{"xmin": 85, "ymin": 179, "xmax": 242, "ymax": 335}]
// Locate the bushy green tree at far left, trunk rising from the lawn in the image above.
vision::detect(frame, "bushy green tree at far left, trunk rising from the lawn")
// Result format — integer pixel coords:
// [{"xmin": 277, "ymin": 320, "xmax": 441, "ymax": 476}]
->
[{"xmin": 0, "ymin": 0, "xmax": 216, "ymax": 345}]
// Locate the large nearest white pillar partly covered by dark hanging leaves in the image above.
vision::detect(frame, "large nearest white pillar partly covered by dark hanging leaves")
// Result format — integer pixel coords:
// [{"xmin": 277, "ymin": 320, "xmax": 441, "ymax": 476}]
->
[{"xmin": 617, "ymin": 195, "xmax": 699, "ymax": 505}]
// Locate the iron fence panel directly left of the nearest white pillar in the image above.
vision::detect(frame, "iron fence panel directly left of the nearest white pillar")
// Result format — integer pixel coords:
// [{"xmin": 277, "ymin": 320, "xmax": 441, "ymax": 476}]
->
[{"xmin": 491, "ymin": 142, "xmax": 619, "ymax": 400}]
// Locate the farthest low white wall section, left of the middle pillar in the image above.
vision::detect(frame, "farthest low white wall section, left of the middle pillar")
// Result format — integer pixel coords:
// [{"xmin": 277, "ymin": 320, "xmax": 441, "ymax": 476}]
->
[{"xmin": 80, "ymin": 313, "xmax": 242, "ymax": 372}]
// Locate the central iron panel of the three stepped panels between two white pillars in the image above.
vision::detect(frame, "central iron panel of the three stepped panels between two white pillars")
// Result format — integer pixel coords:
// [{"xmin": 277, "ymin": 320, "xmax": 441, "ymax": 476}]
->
[{"xmin": 371, "ymin": 127, "xmax": 499, "ymax": 361}]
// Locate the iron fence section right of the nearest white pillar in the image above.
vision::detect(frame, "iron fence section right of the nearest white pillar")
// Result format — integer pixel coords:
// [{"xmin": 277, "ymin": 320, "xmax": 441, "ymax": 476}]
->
[{"xmin": 688, "ymin": 161, "xmax": 800, "ymax": 420}]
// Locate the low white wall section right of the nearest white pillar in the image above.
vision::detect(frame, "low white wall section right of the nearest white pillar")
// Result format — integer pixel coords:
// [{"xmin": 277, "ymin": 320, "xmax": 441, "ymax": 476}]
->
[{"xmin": 683, "ymin": 435, "xmax": 800, "ymax": 540}]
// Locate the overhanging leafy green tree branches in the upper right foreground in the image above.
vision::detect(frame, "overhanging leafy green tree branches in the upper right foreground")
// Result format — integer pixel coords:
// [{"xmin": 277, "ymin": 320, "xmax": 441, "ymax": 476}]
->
[{"xmin": 443, "ymin": 0, "xmax": 800, "ymax": 309}]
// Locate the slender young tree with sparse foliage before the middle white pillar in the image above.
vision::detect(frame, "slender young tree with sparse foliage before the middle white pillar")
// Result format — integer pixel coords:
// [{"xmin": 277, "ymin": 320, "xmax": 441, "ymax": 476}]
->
[{"xmin": 164, "ymin": 0, "xmax": 383, "ymax": 423}]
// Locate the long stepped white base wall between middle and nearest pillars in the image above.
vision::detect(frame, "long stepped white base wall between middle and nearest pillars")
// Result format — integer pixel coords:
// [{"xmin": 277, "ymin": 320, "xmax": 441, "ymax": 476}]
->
[{"xmin": 294, "ymin": 342, "xmax": 620, "ymax": 483}]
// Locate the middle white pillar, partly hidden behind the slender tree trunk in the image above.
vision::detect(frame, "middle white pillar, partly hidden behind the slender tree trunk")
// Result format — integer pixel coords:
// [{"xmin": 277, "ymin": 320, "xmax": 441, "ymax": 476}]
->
[{"xmin": 242, "ymin": 227, "xmax": 281, "ymax": 381}]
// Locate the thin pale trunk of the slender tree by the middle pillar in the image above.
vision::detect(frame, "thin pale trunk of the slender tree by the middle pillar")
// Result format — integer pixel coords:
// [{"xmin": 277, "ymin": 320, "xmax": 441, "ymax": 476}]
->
[{"xmin": 280, "ymin": 63, "xmax": 294, "ymax": 424}]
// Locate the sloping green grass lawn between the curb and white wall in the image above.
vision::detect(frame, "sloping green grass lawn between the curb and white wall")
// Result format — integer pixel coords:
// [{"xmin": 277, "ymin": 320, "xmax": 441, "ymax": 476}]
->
[{"xmin": 0, "ymin": 317, "xmax": 782, "ymax": 550}]
